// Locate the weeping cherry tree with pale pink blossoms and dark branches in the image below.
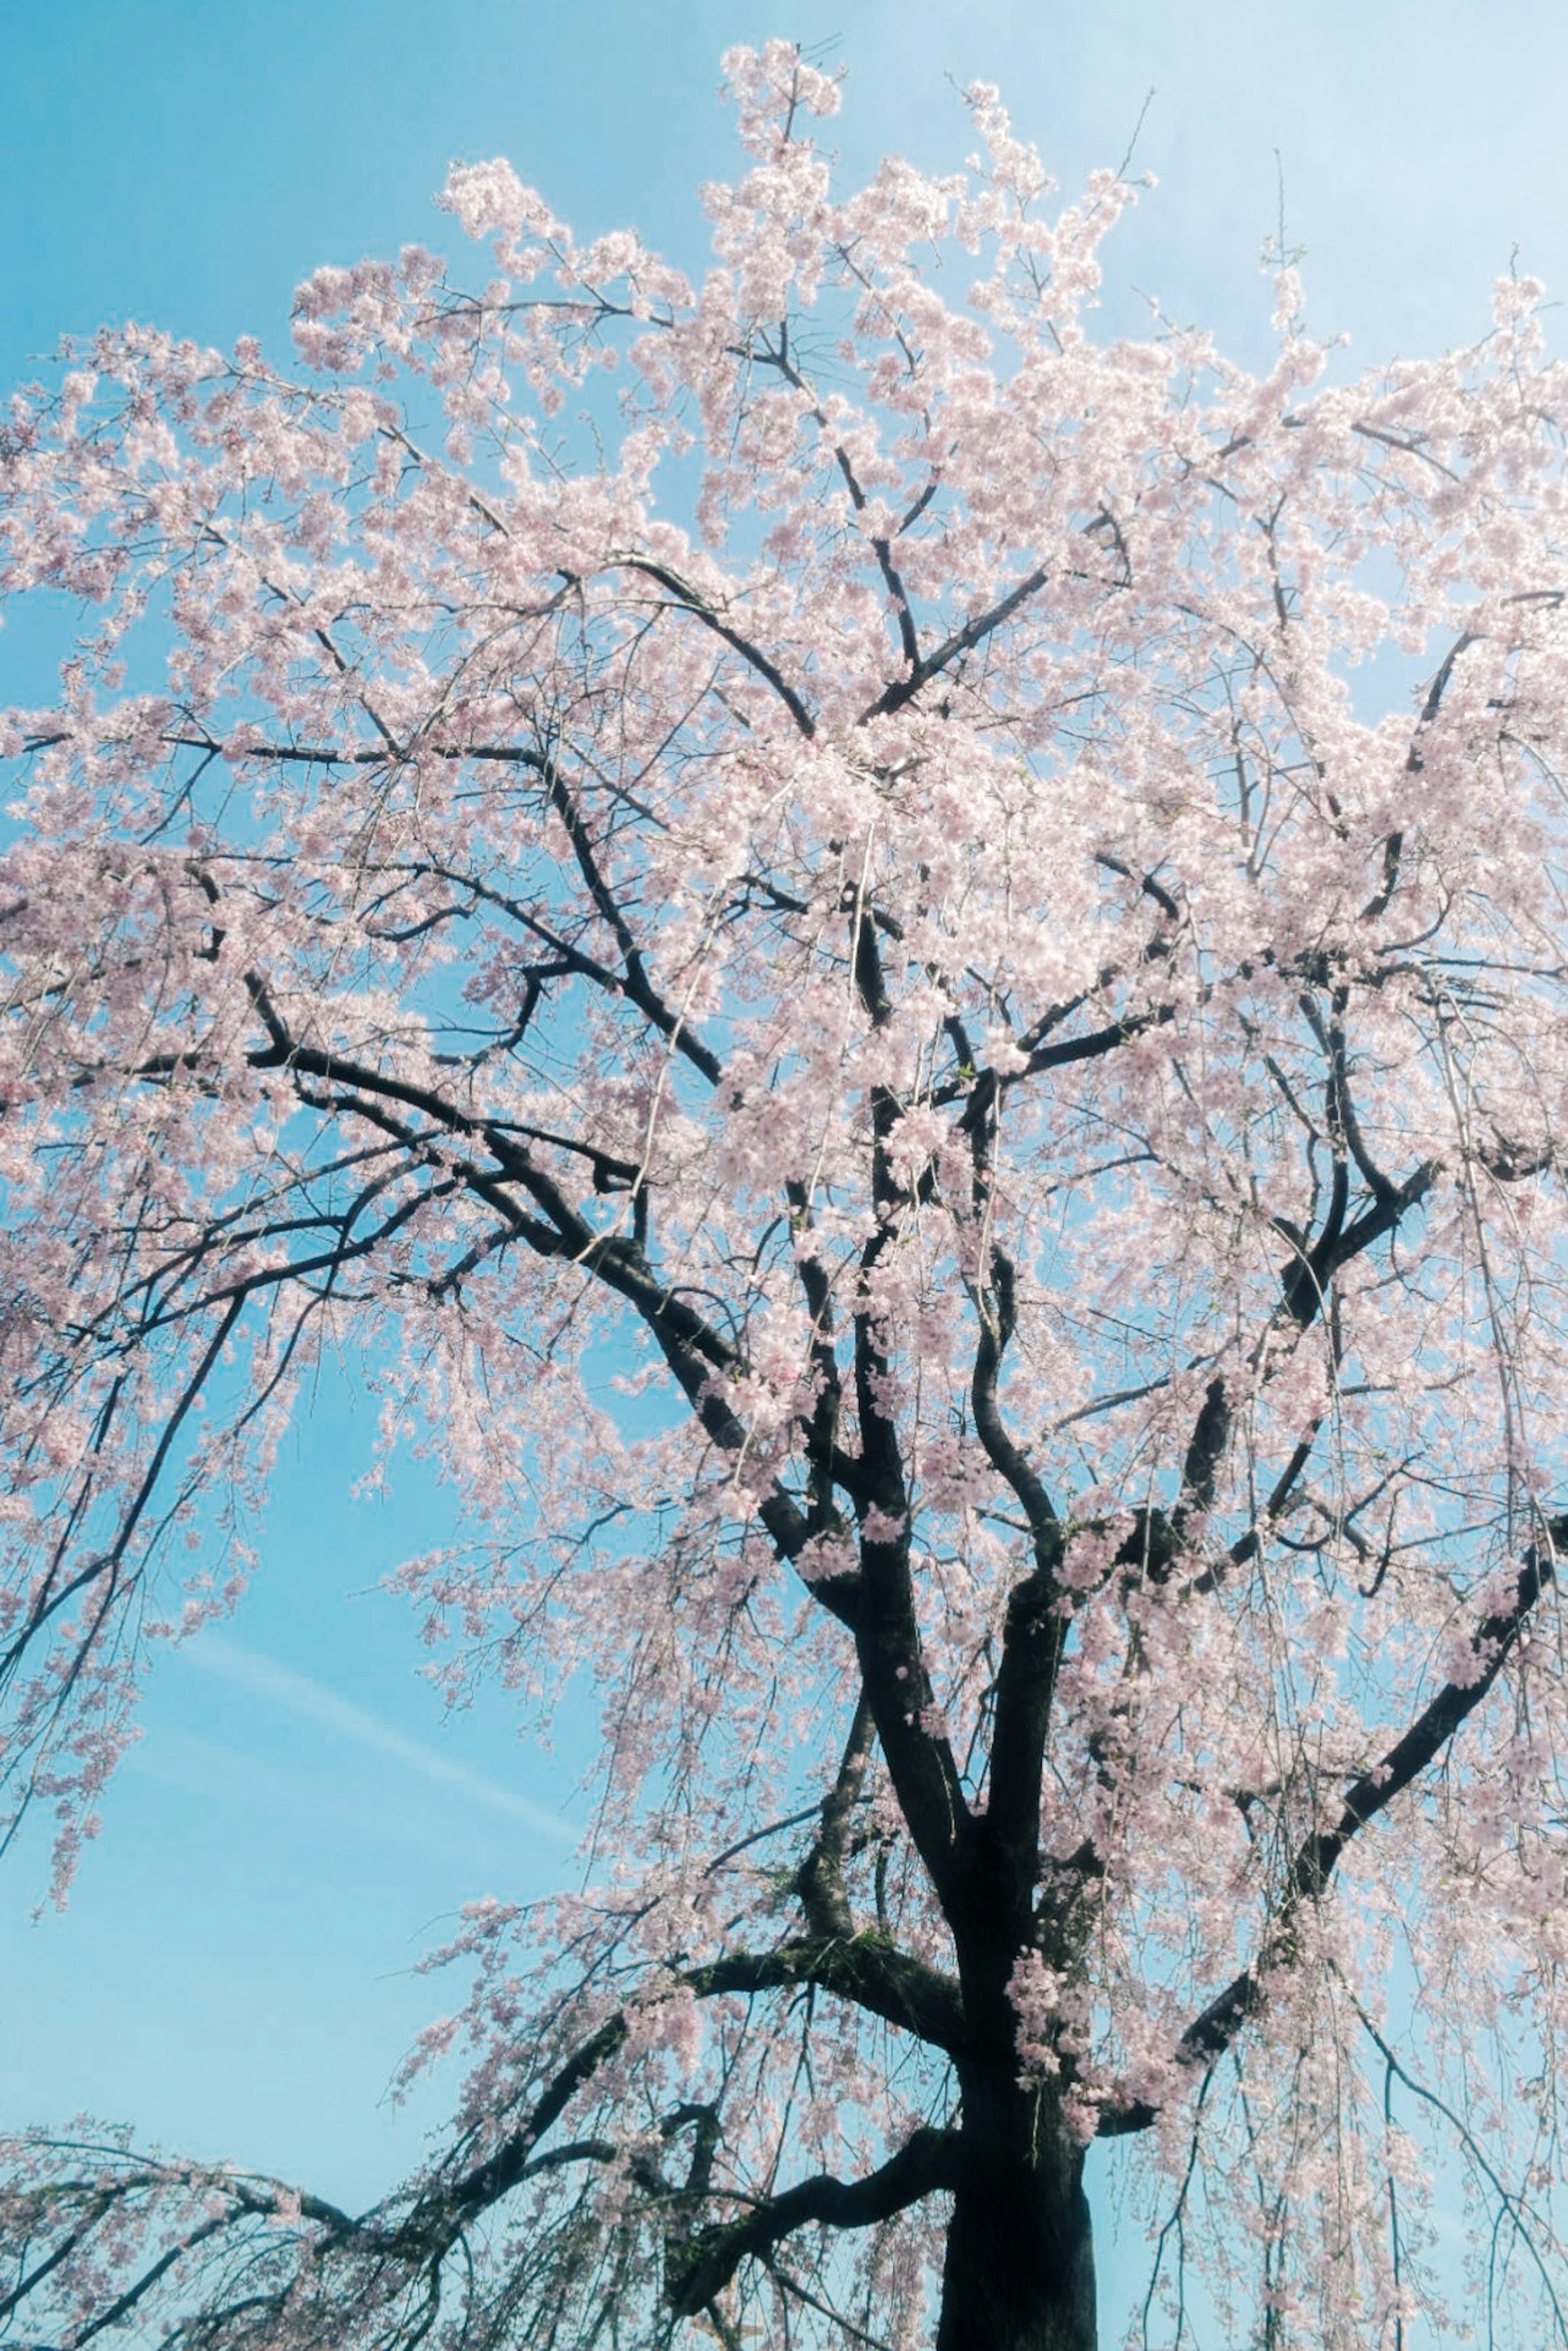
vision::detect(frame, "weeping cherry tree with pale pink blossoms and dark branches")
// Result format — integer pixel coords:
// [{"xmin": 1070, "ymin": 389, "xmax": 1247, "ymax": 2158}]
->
[{"xmin": 0, "ymin": 42, "xmax": 1568, "ymax": 2351}]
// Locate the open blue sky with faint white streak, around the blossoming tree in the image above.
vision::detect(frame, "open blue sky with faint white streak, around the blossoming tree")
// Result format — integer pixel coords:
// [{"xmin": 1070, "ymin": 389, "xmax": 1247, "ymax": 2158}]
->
[{"xmin": 0, "ymin": 0, "xmax": 1568, "ymax": 2313}]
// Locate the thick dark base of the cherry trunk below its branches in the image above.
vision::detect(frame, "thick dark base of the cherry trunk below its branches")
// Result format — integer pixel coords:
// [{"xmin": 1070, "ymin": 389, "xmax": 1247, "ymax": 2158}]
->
[{"xmin": 935, "ymin": 2069, "xmax": 1096, "ymax": 2351}]
